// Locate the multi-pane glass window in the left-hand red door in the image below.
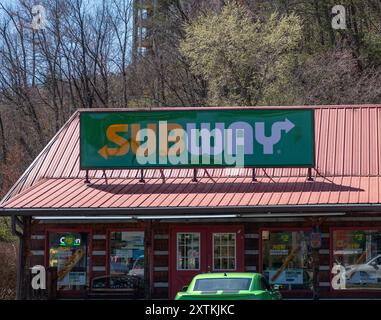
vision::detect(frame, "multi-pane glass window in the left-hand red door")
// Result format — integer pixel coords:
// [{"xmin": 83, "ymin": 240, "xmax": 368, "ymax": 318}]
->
[{"xmin": 177, "ymin": 232, "xmax": 200, "ymax": 270}]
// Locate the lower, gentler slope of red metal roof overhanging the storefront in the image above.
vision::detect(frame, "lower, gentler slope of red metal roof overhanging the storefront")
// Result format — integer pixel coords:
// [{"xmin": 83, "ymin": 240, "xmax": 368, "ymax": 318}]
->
[{"xmin": 2, "ymin": 177, "xmax": 381, "ymax": 209}]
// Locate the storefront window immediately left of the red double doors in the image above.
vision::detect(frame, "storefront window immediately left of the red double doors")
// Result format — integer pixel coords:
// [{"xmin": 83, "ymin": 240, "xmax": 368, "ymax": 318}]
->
[{"xmin": 109, "ymin": 231, "xmax": 144, "ymax": 283}]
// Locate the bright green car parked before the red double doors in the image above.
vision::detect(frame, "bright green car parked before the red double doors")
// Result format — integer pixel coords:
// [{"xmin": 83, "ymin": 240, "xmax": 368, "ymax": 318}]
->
[{"xmin": 175, "ymin": 272, "xmax": 282, "ymax": 300}]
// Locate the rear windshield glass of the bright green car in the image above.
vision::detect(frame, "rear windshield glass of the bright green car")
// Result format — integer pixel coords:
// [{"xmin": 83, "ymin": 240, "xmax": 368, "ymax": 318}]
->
[{"xmin": 193, "ymin": 278, "xmax": 251, "ymax": 291}]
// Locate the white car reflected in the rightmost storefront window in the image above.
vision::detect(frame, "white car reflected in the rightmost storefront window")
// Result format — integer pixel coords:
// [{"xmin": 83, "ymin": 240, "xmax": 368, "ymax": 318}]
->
[{"xmin": 345, "ymin": 255, "xmax": 381, "ymax": 283}]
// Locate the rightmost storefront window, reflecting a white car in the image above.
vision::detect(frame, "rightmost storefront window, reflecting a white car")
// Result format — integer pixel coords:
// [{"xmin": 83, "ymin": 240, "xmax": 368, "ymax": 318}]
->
[{"xmin": 333, "ymin": 230, "xmax": 381, "ymax": 289}]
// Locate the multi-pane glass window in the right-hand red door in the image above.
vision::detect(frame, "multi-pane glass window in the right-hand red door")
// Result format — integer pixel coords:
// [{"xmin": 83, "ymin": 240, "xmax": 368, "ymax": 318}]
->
[{"xmin": 213, "ymin": 233, "xmax": 236, "ymax": 270}]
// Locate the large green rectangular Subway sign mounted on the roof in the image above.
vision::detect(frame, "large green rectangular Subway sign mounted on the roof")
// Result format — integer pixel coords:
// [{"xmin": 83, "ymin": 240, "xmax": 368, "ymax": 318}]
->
[{"xmin": 80, "ymin": 108, "xmax": 315, "ymax": 169}]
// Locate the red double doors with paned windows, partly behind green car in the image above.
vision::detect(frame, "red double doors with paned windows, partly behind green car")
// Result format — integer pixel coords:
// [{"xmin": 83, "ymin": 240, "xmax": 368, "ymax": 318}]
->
[{"xmin": 169, "ymin": 226, "xmax": 244, "ymax": 298}]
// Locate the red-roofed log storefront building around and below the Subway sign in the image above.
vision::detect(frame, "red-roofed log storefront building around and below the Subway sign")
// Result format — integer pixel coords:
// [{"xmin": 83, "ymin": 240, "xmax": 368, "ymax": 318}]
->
[{"xmin": 0, "ymin": 105, "xmax": 381, "ymax": 299}]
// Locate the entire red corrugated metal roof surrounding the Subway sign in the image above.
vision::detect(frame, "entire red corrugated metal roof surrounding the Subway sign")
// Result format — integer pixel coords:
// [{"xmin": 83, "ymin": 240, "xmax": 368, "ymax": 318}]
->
[{"xmin": 0, "ymin": 105, "xmax": 381, "ymax": 208}]
